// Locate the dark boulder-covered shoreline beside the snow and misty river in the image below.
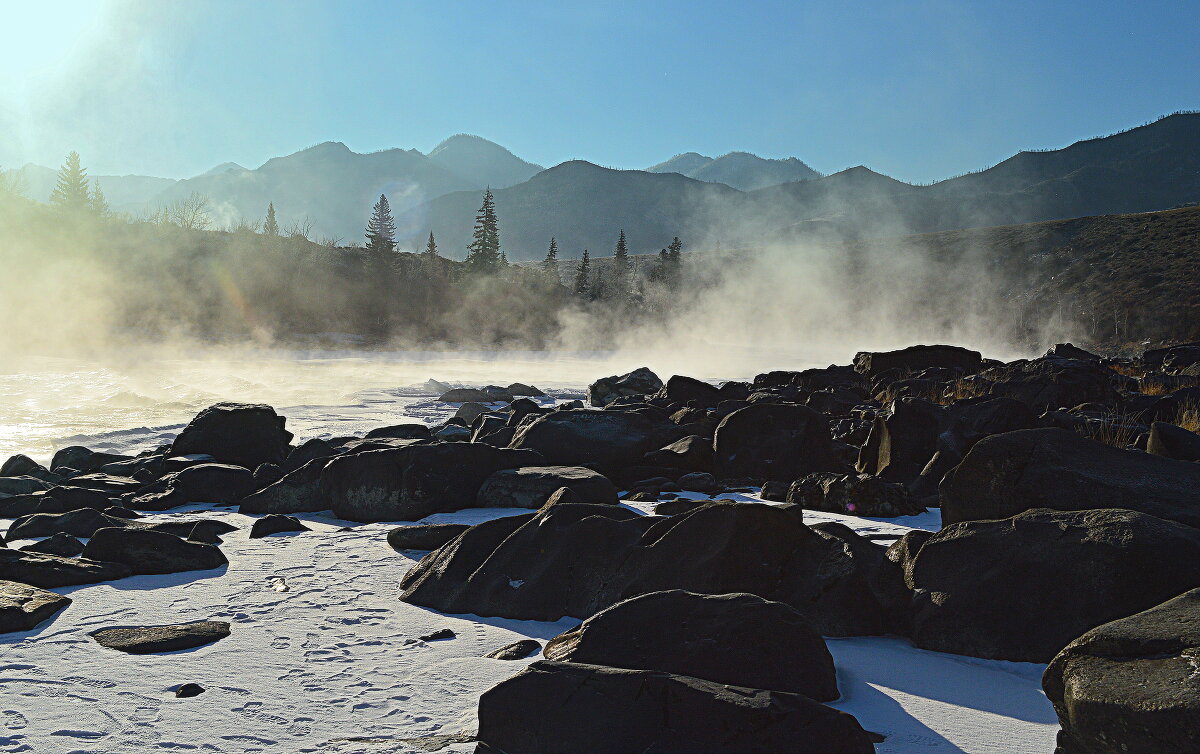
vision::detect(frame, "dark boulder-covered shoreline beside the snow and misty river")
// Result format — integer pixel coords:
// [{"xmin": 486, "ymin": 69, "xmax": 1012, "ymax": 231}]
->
[{"xmin": 0, "ymin": 343, "xmax": 1200, "ymax": 754}]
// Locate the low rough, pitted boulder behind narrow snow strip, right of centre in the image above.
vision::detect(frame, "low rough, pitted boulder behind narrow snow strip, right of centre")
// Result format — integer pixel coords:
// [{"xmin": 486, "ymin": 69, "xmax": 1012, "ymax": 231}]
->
[{"xmin": 787, "ymin": 472, "xmax": 925, "ymax": 519}]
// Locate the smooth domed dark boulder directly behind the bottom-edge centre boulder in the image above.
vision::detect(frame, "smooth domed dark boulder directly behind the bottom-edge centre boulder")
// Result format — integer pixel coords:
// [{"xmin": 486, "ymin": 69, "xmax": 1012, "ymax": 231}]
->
[{"xmin": 542, "ymin": 590, "xmax": 839, "ymax": 701}]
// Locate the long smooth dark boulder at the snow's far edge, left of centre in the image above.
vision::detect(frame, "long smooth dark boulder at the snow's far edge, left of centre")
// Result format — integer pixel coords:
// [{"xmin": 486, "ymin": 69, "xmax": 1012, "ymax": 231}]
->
[{"xmin": 320, "ymin": 443, "xmax": 545, "ymax": 521}]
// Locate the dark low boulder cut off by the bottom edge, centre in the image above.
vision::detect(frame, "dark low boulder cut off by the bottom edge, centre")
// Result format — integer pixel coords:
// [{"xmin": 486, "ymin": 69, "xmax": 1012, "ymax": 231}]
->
[{"xmin": 479, "ymin": 660, "xmax": 875, "ymax": 754}]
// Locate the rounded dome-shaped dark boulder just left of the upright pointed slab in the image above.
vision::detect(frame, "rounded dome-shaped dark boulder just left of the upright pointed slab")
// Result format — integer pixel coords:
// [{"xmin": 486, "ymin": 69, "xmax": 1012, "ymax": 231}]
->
[{"xmin": 713, "ymin": 403, "xmax": 841, "ymax": 481}]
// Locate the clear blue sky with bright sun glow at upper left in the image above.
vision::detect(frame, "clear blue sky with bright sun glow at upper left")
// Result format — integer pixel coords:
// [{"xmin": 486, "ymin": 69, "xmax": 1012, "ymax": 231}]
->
[{"xmin": 0, "ymin": 0, "xmax": 1200, "ymax": 181}]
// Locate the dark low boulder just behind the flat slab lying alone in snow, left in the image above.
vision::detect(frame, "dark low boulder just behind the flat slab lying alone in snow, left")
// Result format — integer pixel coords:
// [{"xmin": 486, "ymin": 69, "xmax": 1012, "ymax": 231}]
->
[{"xmin": 83, "ymin": 528, "xmax": 229, "ymax": 574}]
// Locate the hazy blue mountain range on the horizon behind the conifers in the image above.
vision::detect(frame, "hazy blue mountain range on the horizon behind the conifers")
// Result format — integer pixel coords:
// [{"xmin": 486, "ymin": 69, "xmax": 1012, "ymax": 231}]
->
[{"xmin": 9, "ymin": 113, "xmax": 1200, "ymax": 261}]
